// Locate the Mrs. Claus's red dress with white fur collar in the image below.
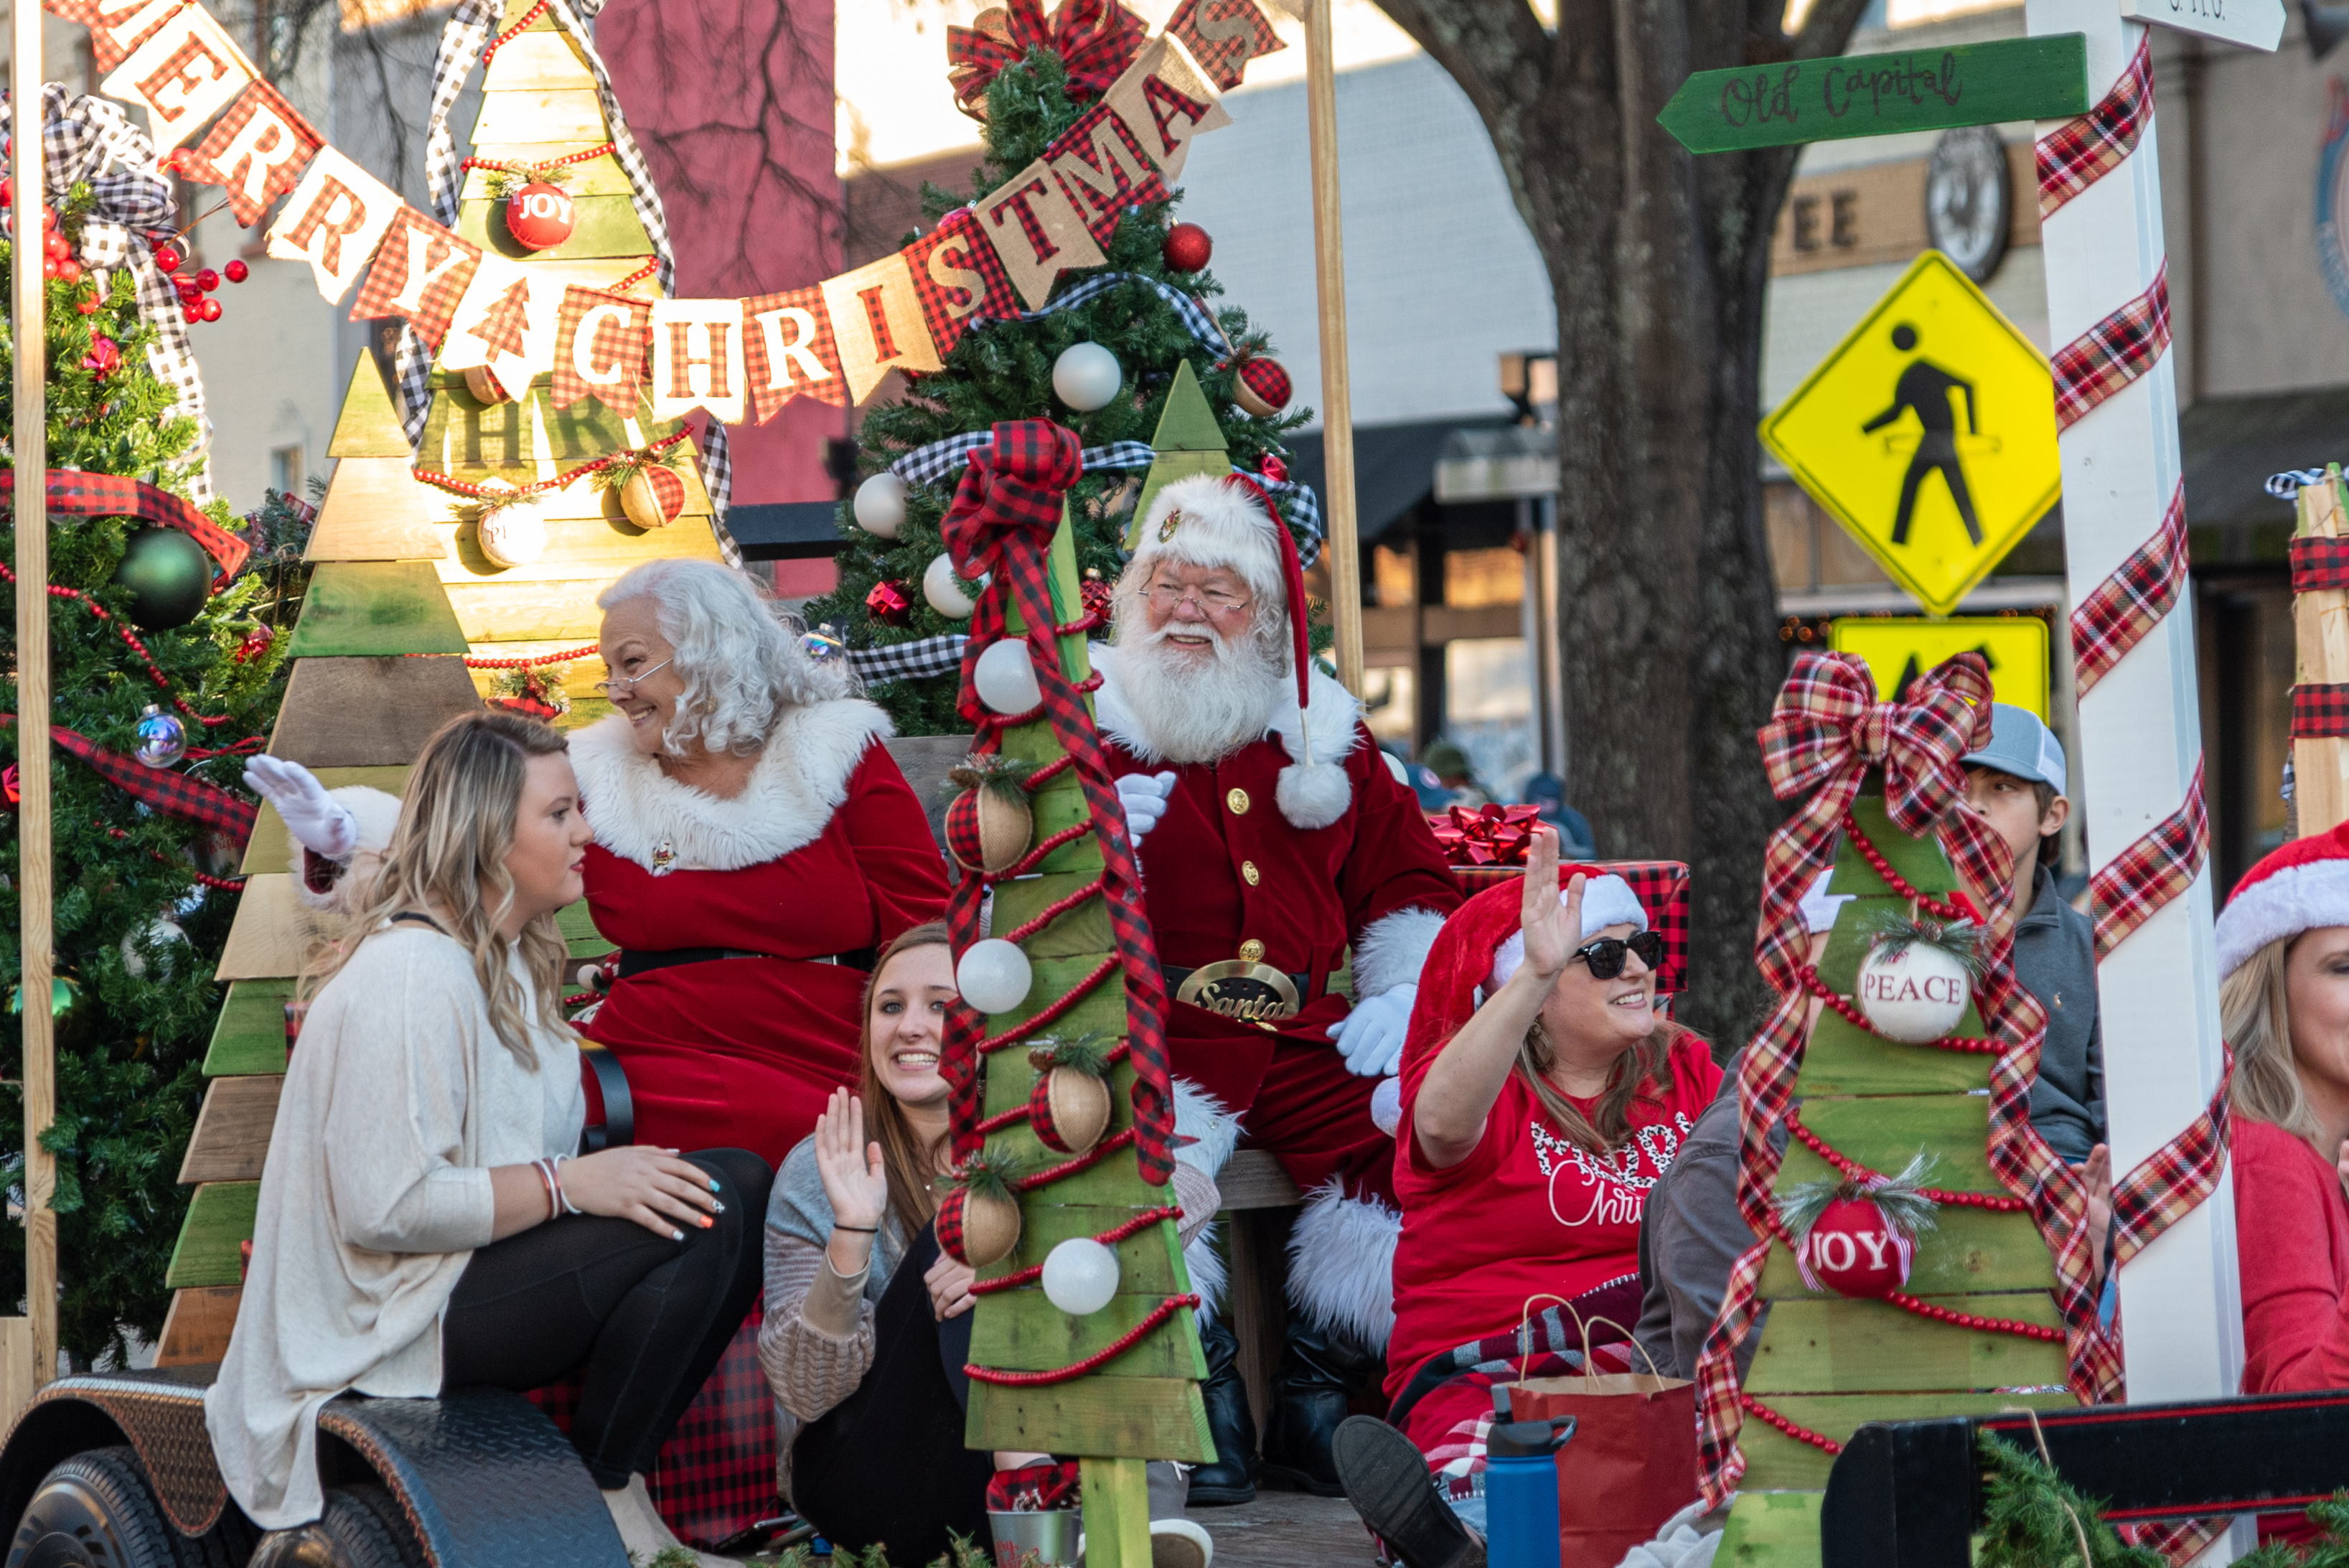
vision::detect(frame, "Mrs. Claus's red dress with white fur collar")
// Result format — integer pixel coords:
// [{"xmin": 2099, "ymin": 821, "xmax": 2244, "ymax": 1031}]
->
[{"xmin": 571, "ymin": 700, "xmax": 947, "ymax": 1167}]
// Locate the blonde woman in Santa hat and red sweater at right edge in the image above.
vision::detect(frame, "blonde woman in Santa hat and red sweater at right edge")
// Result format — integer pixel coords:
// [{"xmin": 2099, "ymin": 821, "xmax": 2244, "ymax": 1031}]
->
[{"xmin": 2218, "ymin": 824, "xmax": 2349, "ymax": 1540}]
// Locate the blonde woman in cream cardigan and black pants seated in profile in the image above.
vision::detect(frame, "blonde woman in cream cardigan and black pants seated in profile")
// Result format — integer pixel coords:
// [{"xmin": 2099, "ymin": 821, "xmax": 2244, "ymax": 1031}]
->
[{"xmin": 205, "ymin": 713, "xmax": 771, "ymax": 1561}]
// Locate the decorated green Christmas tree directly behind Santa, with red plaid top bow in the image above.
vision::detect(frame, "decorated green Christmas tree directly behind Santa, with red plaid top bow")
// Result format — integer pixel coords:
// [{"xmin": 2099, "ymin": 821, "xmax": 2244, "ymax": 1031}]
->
[{"xmin": 808, "ymin": 34, "xmax": 1320, "ymax": 735}]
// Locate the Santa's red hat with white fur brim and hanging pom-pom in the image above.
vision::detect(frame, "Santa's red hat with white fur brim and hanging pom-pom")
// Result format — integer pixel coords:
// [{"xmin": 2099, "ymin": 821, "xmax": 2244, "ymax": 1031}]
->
[{"xmin": 1127, "ymin": 471, "xmax": 1353, "ymax": 829}]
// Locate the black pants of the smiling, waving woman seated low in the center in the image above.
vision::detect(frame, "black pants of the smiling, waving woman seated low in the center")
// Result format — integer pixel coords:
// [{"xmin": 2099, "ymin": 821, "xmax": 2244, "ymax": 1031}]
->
[{"xmin": 792, "ymin": 1230, "xmax": 996, "ymax": 1563}]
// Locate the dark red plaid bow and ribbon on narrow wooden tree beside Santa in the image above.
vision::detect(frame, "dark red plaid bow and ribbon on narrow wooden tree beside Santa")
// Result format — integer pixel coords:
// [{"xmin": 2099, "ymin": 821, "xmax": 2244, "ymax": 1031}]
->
[{"xmin": 939, "ymin": 421, "xmax": 1175, "ymax": 1186}]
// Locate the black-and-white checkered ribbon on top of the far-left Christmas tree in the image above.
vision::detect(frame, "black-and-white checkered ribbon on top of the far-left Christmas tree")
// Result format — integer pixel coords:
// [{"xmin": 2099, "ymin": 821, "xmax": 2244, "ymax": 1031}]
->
[{"xmin": 0, "ymin": 82, "xmax": 212, "ymax": 495}]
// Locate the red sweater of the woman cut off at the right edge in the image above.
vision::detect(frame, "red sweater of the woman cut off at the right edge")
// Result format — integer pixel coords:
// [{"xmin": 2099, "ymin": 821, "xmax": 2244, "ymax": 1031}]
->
[{"xmin": 2234, "ymin": 1115, "xmax": 2349, "ymax": 1394}]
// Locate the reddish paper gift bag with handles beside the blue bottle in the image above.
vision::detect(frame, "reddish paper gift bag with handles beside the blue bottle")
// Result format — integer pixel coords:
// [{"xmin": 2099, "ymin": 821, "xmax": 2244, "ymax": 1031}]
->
[{"xmin": 1494, "ymin": 1296, "xmax": 1696, "ymax": 1568}]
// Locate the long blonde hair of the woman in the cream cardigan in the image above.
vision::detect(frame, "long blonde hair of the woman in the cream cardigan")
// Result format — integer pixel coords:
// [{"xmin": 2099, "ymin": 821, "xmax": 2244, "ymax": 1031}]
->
[{"xmin": 301, "ymin": 711, "xmax": 568, "ymax": 1073}]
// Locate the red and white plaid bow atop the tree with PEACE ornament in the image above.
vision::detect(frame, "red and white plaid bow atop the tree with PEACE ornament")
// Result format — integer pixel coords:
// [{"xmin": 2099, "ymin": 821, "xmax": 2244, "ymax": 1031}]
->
[{"xmin": 1755, "ymin": 652, "xmax": 2011, "ymax": 990}]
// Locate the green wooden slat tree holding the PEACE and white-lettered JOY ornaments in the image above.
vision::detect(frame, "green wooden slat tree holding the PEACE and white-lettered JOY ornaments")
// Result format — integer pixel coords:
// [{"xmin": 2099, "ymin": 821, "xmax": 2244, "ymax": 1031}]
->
[{"xmin": 1717, "ymin": 794, "xmax": 2076, "ymax": 1568}]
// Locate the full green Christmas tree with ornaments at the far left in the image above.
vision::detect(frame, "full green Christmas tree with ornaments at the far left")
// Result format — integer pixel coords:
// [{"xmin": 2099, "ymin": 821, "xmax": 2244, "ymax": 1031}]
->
[{"xmin": 0, "ymin": 152, "xmax": 301, "ymax": 1363}]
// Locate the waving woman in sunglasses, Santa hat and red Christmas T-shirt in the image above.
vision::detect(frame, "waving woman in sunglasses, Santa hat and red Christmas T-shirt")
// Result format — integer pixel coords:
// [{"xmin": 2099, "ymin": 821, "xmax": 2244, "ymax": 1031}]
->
[{"xmin": 1334, "ymin": 826, "xmax": 1722, "ymax": 1568}]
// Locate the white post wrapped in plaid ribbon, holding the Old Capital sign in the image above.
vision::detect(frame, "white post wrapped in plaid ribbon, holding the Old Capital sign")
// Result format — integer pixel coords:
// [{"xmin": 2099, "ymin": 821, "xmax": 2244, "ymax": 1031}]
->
[{"xmin": 2027, "ymin": 0, "xmax": 2251, "ymax": 1561}]
